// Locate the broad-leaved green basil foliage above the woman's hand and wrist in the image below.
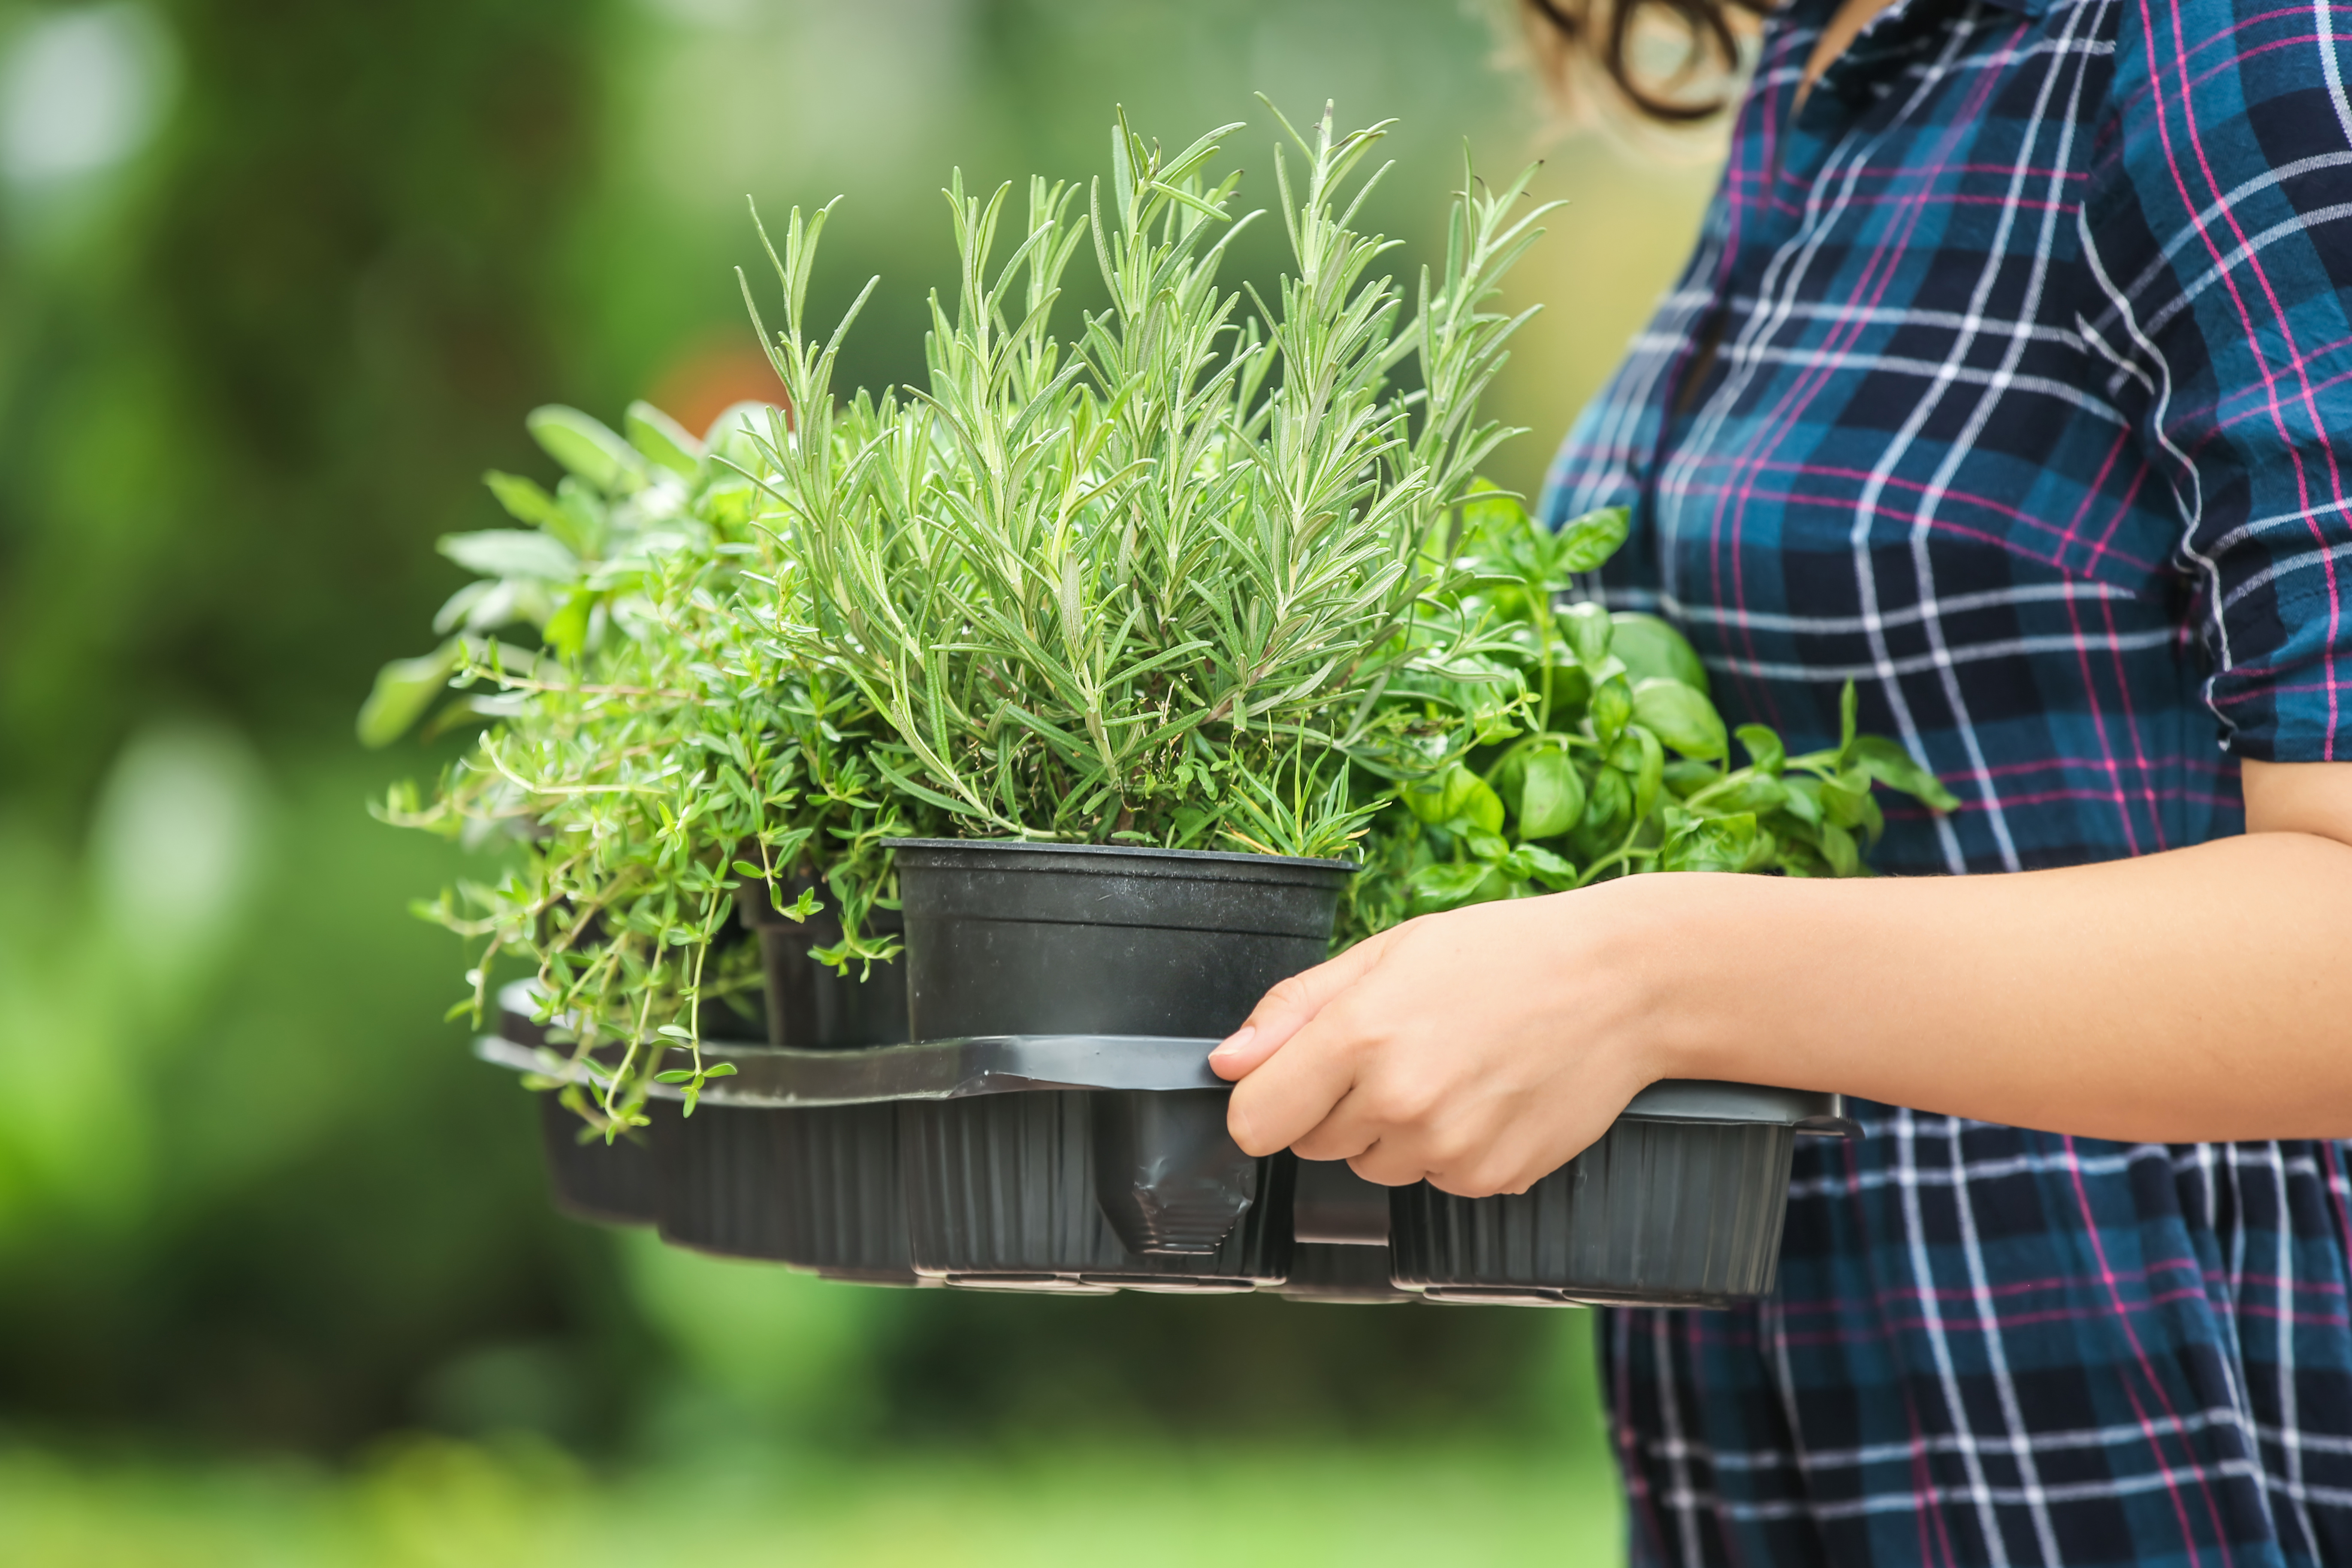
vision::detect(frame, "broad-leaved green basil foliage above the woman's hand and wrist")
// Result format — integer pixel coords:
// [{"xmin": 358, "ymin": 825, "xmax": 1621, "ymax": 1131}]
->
[{"xmin": 1345, "ymin": 491, "xmax": 1959, "ymax": 938}]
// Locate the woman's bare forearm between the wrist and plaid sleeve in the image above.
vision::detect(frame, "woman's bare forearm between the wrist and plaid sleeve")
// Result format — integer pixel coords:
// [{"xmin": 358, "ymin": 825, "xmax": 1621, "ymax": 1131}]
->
[{"xmin": 1656, "ymin": 832, "xmax": 2352, "ymax": 1142}]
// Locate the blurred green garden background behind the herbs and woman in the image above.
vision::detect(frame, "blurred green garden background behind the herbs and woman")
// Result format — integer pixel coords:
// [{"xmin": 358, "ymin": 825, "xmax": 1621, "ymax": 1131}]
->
[{"xmin": 0, "ymin": 0, "xmax": 1710, "ymax": 1563}]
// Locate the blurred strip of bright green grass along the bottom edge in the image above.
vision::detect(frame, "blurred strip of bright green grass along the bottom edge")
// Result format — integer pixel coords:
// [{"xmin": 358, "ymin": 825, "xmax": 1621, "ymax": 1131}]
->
[{"xmin": 0, "ymin": 1439, "xmax": 1623, "ymax": 1568}]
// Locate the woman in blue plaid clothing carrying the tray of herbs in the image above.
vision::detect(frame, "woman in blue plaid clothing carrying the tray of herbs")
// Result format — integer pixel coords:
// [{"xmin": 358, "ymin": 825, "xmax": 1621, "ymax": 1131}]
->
[{"xmin": 1214, "ymin": 0, "xmax": 2352, "ymax": 1568}]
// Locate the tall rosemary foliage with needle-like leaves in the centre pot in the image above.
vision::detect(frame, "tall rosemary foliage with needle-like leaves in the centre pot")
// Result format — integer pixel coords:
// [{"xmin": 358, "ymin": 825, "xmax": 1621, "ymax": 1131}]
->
[{"xmin": 746, "ymin": 108, "xmax": 1548, "ymax": 856}]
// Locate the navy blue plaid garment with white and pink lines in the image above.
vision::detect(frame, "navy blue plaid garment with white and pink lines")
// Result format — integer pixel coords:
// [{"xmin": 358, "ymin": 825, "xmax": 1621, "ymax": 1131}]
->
[{"xmin": 1543, "ymin": 0, "xmax": 2352, "ymax": 1568}]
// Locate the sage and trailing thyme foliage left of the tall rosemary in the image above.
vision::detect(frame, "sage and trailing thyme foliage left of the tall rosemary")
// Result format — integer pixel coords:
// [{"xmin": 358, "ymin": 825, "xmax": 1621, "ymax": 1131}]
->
[{"xmin": 360, "ymin": 405, "xmax": 910, "ymax": 1136}]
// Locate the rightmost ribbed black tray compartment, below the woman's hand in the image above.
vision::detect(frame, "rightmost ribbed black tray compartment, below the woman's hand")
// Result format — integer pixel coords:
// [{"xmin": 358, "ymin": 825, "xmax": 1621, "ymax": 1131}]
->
[{"xmin": 1390, "ymin": 1114, "xmax": 1797, "ymax": 1307}]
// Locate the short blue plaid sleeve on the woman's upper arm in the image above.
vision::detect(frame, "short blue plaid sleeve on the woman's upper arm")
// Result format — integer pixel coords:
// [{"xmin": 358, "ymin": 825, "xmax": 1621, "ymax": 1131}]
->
[{"xmin": 2081, "ymin": 0, "xmax": 2352, "ymax": 761}]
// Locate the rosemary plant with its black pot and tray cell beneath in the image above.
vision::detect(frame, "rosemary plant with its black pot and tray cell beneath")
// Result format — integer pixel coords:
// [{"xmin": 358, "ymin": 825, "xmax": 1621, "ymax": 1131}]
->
[{"xmin": 746, "ymin": 111, "xmax": 1543, "ymax": 1288}]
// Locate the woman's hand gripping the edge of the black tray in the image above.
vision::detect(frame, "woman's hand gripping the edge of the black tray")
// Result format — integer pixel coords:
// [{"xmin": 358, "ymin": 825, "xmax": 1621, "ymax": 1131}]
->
[{"xmin": 1209, "ymin": 877, "xmax": 1722, "ymax": 1196}]
